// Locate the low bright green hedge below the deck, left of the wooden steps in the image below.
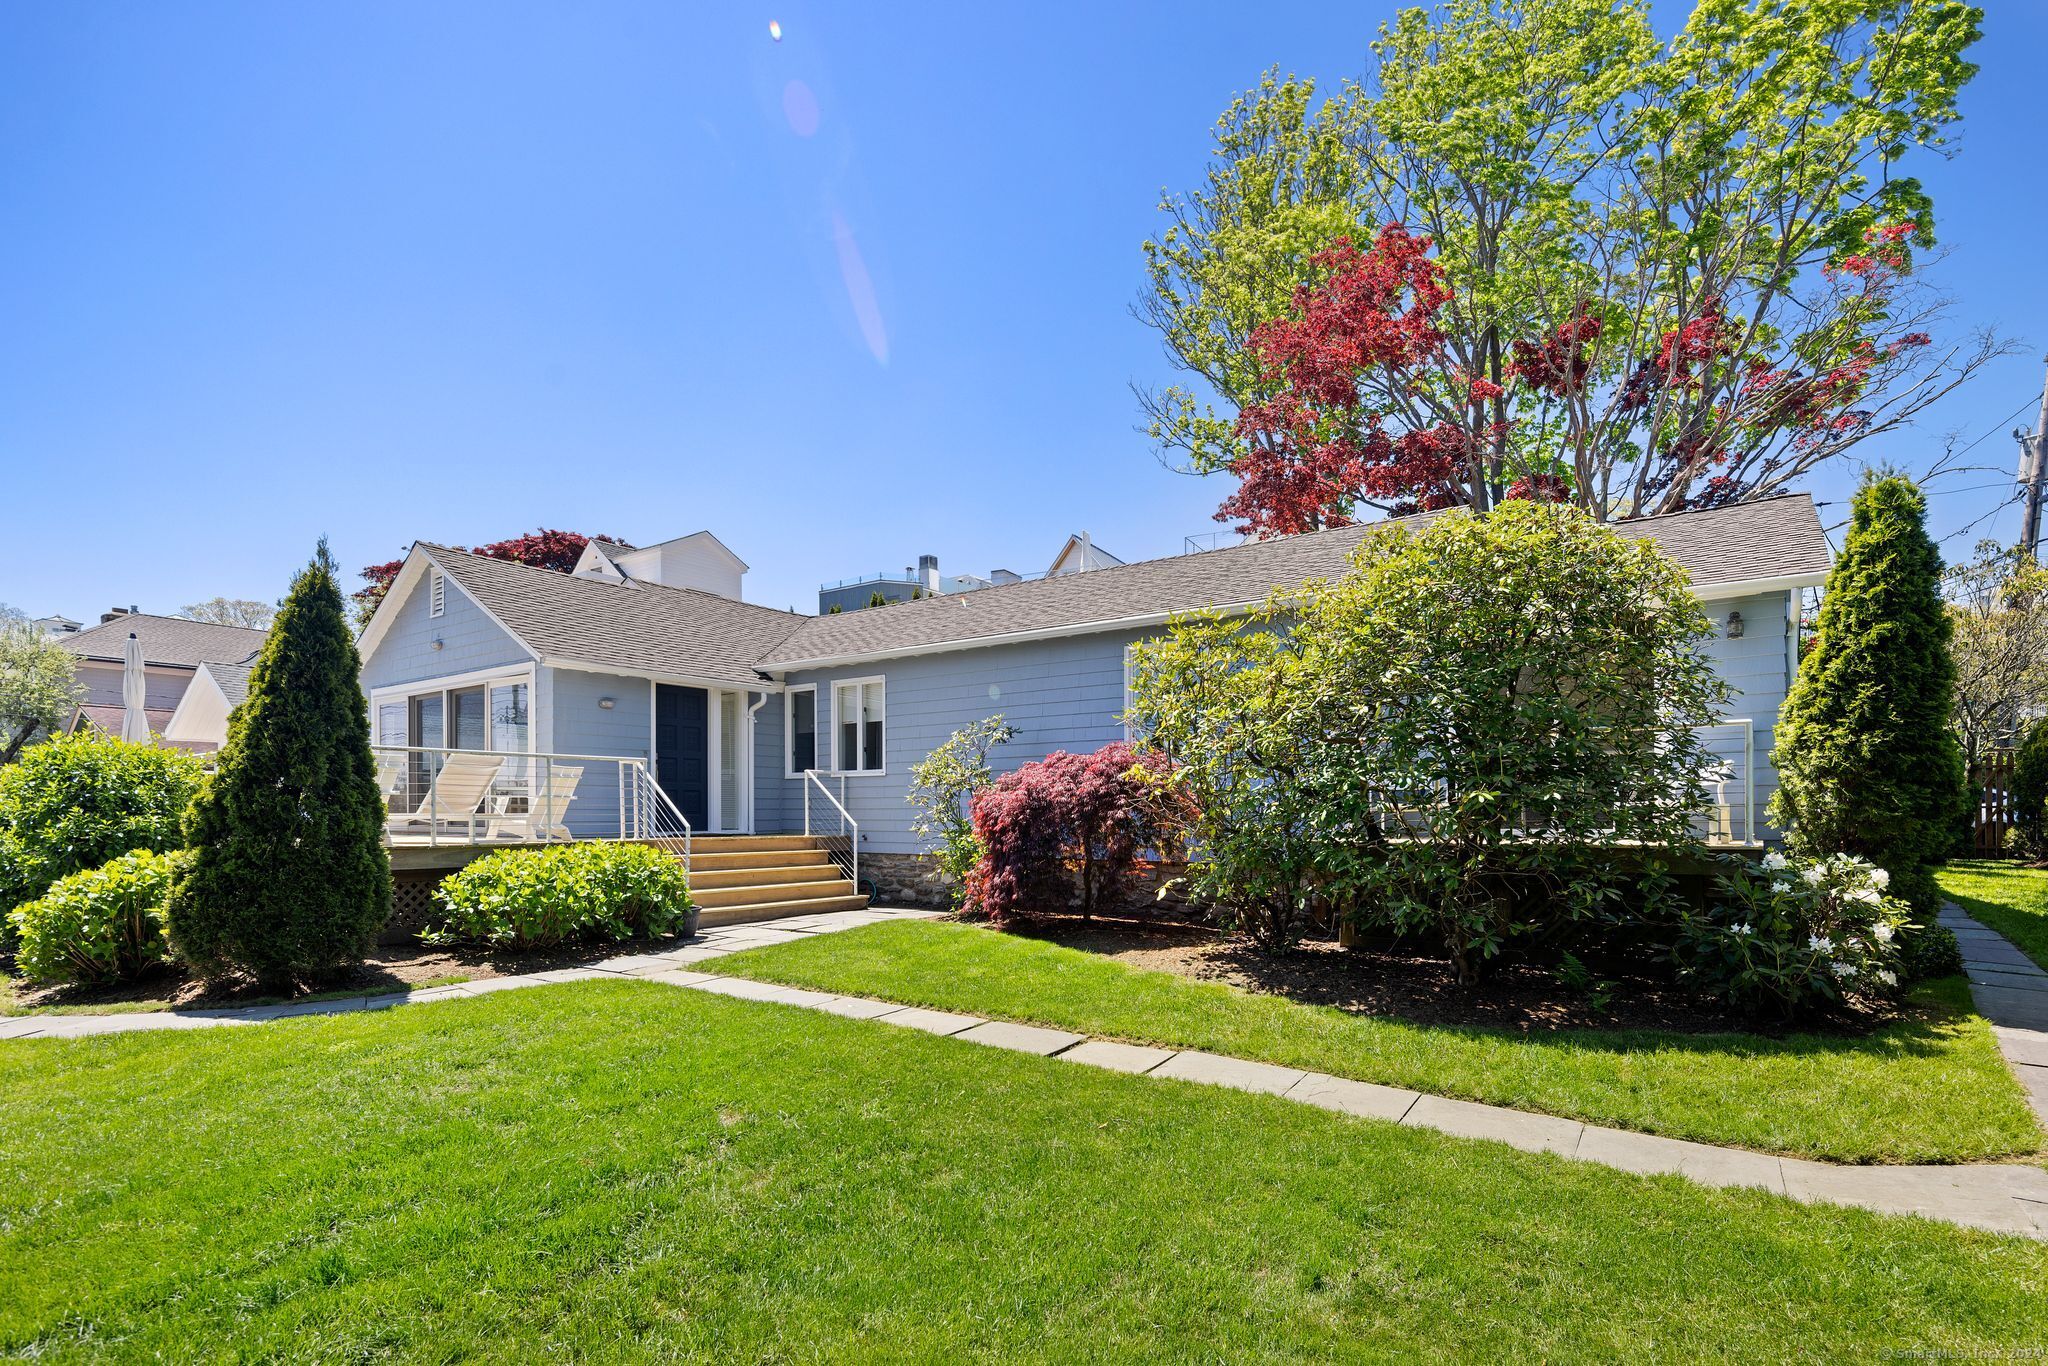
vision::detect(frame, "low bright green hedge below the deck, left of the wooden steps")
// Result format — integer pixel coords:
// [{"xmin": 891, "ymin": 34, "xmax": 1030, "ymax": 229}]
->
[{"xmin": 420, "ymin": 844, "xmax": 692, "ymax": 948}]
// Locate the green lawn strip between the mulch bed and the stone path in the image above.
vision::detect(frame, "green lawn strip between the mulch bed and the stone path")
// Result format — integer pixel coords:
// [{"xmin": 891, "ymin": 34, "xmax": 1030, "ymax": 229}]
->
[{"xmin": 698, "ymin": 922, "xmax": 2042, "ymax": 1161}]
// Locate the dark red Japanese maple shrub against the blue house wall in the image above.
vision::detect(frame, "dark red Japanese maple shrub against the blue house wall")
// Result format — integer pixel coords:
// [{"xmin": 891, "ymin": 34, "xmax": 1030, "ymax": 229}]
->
[{"xmin": 967, "ymin": 741, "xmax": 1188, "ymax": 924}]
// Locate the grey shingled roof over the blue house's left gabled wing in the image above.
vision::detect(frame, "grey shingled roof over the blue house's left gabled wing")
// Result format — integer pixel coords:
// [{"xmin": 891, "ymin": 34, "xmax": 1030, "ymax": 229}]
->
[{"xmin": 420, "ymin": 545, "xmax": 809, "ymax": 686}]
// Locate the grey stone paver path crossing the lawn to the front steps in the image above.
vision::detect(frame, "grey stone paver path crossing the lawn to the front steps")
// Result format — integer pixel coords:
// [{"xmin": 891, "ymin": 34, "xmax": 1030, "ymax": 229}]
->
[{"xmin": 12, "ymin": 907, "xmax": 2048, "ymax": 1239}]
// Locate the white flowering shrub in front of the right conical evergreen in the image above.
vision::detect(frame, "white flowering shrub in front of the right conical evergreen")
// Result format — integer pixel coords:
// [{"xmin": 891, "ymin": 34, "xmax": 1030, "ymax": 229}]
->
[{"xmin": 1671, "ymin": 852, "xmax": 1911, "ymax": 1018}]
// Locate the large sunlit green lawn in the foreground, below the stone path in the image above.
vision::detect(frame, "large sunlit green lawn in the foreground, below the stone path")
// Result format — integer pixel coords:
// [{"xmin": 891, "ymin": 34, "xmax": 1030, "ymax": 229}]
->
[{"xmin": 0, "ymin": 981, "xmax": 2048, "ymax": 1362}]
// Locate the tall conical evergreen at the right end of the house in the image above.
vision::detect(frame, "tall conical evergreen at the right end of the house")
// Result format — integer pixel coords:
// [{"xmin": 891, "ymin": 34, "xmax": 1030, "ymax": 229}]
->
[{"xmin": 1772, "ymin": 475, "xmax": 1964, "ymax": 922}]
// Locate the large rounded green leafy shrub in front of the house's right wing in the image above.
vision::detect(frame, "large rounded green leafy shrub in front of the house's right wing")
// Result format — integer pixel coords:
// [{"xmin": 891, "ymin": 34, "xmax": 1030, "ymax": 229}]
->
[{"xmin": 1133, "ymin": 502, "xmax": 1726, "ymax": 981}]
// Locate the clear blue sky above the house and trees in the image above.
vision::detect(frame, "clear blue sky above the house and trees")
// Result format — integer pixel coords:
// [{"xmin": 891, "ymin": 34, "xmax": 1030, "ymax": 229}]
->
[{"xmin": 0, "ymin": 2, "xmax": 2048, "ymax": 621}]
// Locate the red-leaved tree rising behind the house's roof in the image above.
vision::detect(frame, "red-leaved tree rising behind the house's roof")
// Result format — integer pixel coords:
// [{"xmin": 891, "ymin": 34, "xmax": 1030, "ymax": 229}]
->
[{"xmin": 1217, "ymin": 223, "xmax": 1954, "ymax": 535}]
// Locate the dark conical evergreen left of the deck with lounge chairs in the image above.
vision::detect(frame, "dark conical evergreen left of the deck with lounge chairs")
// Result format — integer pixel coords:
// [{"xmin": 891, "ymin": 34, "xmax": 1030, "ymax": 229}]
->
[{"xmin": 168, "ymin": 541, "xmax": 391, "ymax": 983}]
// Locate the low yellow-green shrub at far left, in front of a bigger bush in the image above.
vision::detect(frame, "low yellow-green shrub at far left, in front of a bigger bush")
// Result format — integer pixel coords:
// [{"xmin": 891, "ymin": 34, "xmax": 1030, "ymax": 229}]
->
[{"xmin": 8, "ymin": 850, "xmax": 188, "ymax": 983}]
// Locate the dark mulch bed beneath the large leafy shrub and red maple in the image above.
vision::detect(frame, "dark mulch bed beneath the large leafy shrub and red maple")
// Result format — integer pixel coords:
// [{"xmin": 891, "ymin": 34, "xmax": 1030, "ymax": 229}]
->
[{"xmin": 1016, "ymin": 917, "xmax": 1888, "ymax": 1034}]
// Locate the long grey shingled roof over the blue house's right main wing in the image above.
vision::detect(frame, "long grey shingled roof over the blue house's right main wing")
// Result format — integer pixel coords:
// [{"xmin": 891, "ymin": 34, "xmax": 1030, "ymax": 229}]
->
[{"xmin": 762, "ymin": 494, "xmax": 1833, "ymax": 670}]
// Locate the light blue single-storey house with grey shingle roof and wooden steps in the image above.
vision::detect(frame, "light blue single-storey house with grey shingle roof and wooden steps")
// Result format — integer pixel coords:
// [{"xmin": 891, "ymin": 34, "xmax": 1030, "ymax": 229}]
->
[{"xmin": 360, "ymin": 494, "xmax": 1831, "ymax": 907}]
